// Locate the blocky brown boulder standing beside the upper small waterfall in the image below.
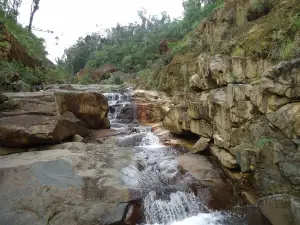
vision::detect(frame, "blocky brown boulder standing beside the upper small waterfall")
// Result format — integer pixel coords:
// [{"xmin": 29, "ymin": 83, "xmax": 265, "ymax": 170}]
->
[{"xmin": 55, "ymin": 92, "xmax": 110, "ymax": 129}]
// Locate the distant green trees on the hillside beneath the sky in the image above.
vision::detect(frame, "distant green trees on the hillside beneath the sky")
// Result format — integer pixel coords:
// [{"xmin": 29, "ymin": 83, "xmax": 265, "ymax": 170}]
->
[{"xmin": 60, "ymin": 0, "xmax": 223, "ymax": 74}]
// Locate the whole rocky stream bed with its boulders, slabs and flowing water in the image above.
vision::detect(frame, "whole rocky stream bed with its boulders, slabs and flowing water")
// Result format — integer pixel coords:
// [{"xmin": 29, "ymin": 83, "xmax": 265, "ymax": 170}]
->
[{"xmin": 0, "ymin": 85, "xmax": 298, "ymax": 225}]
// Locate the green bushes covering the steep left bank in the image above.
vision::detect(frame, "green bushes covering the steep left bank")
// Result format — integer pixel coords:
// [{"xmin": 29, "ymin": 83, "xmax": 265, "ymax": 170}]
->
[{"xmin": 0, "ymin": 0, "xmax": 72, "ymax": 90}]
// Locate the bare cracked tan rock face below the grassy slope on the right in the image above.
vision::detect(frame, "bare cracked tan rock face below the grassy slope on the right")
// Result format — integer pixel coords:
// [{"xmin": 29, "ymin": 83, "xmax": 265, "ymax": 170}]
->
[{"xmin": 163, "ymin": 55, "xmax": 300, "ymax": 194}]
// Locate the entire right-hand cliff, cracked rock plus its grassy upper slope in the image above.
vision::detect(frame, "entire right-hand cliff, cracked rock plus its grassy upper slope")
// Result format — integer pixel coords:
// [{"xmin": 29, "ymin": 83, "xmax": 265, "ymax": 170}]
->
[{"xmin": 146, "ymin": 0, "xmax": 300, "ymax": 196}]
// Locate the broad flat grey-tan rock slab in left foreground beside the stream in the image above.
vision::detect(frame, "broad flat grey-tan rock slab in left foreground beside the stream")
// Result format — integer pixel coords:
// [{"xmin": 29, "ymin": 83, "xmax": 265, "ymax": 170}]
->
[{"xmin": 0, "ymin": 143, "xmax": 137, "ymax": 225}]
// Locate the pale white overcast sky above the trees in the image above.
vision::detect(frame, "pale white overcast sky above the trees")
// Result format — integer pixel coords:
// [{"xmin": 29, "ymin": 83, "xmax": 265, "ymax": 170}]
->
[{"xmin": 18, "ymin": 0, "xmax": 183, "ymax": 61}]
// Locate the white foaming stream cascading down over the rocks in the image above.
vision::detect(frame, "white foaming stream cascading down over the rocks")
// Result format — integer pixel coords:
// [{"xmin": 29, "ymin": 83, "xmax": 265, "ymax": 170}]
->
[{"xmin": 104, "ymin": 90, "xmax": 247, "ymax": 225}]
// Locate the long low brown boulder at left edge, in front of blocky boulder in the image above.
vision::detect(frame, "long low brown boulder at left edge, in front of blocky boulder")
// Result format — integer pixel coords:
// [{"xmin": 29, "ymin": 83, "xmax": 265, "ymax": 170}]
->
[{"xmin": 0, "ymin": 112, "xmax": 88, "ymax": 147}]
